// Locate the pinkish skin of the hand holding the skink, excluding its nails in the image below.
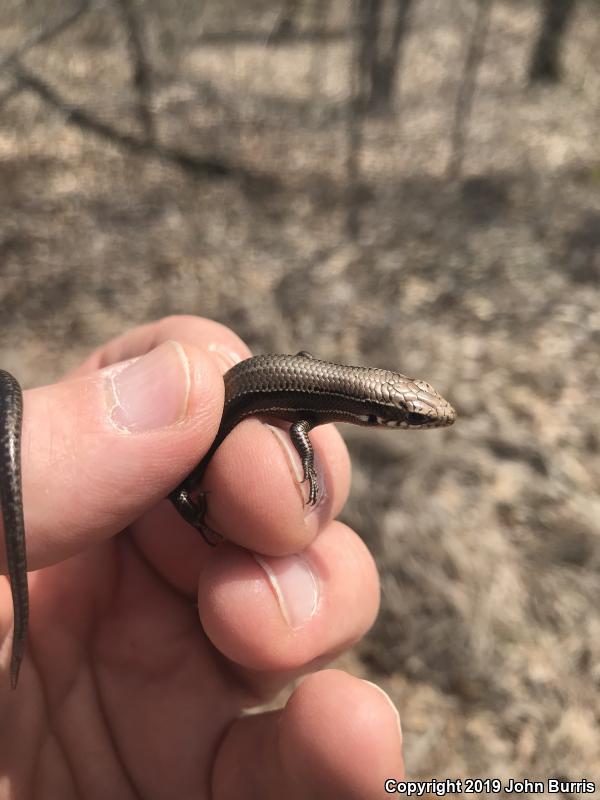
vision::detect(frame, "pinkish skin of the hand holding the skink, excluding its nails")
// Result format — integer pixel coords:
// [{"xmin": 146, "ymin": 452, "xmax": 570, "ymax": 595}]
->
[{"xmin": 0, "ymin": 317, "xmax": 404, "ymax": 800}]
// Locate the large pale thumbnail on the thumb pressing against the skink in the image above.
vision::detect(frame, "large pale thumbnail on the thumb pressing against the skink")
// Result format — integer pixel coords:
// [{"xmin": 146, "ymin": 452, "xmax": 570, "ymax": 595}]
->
[{"xmin": 107, "ymin": 342, "xmax": 190, "ymax": 432}]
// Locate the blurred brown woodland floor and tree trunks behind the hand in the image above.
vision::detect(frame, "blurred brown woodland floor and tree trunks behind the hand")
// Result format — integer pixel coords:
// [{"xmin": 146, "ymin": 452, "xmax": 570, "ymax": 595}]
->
[{"xmin": 0, "ymin": 0, "xmax": 600, "ymax": 781}]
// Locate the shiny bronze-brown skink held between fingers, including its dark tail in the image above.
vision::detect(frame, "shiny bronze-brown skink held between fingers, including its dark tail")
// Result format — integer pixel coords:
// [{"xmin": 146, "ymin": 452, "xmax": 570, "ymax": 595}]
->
[{"xmin": 0, "ymin": 352, "xmax": 455, "ymax": 688}]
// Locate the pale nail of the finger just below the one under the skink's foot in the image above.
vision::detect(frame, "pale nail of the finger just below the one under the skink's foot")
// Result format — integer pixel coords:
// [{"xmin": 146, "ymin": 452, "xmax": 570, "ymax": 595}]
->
[{"xmin": 253, "ymin": 553, "xmax": 319, "ymax": 628}]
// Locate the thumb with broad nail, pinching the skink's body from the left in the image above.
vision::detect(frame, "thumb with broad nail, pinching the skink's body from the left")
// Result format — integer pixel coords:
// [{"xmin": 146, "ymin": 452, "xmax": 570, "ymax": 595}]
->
[{"xmin": 3, "ymin": 341, "xmax": 223, "ymax": 570}]
